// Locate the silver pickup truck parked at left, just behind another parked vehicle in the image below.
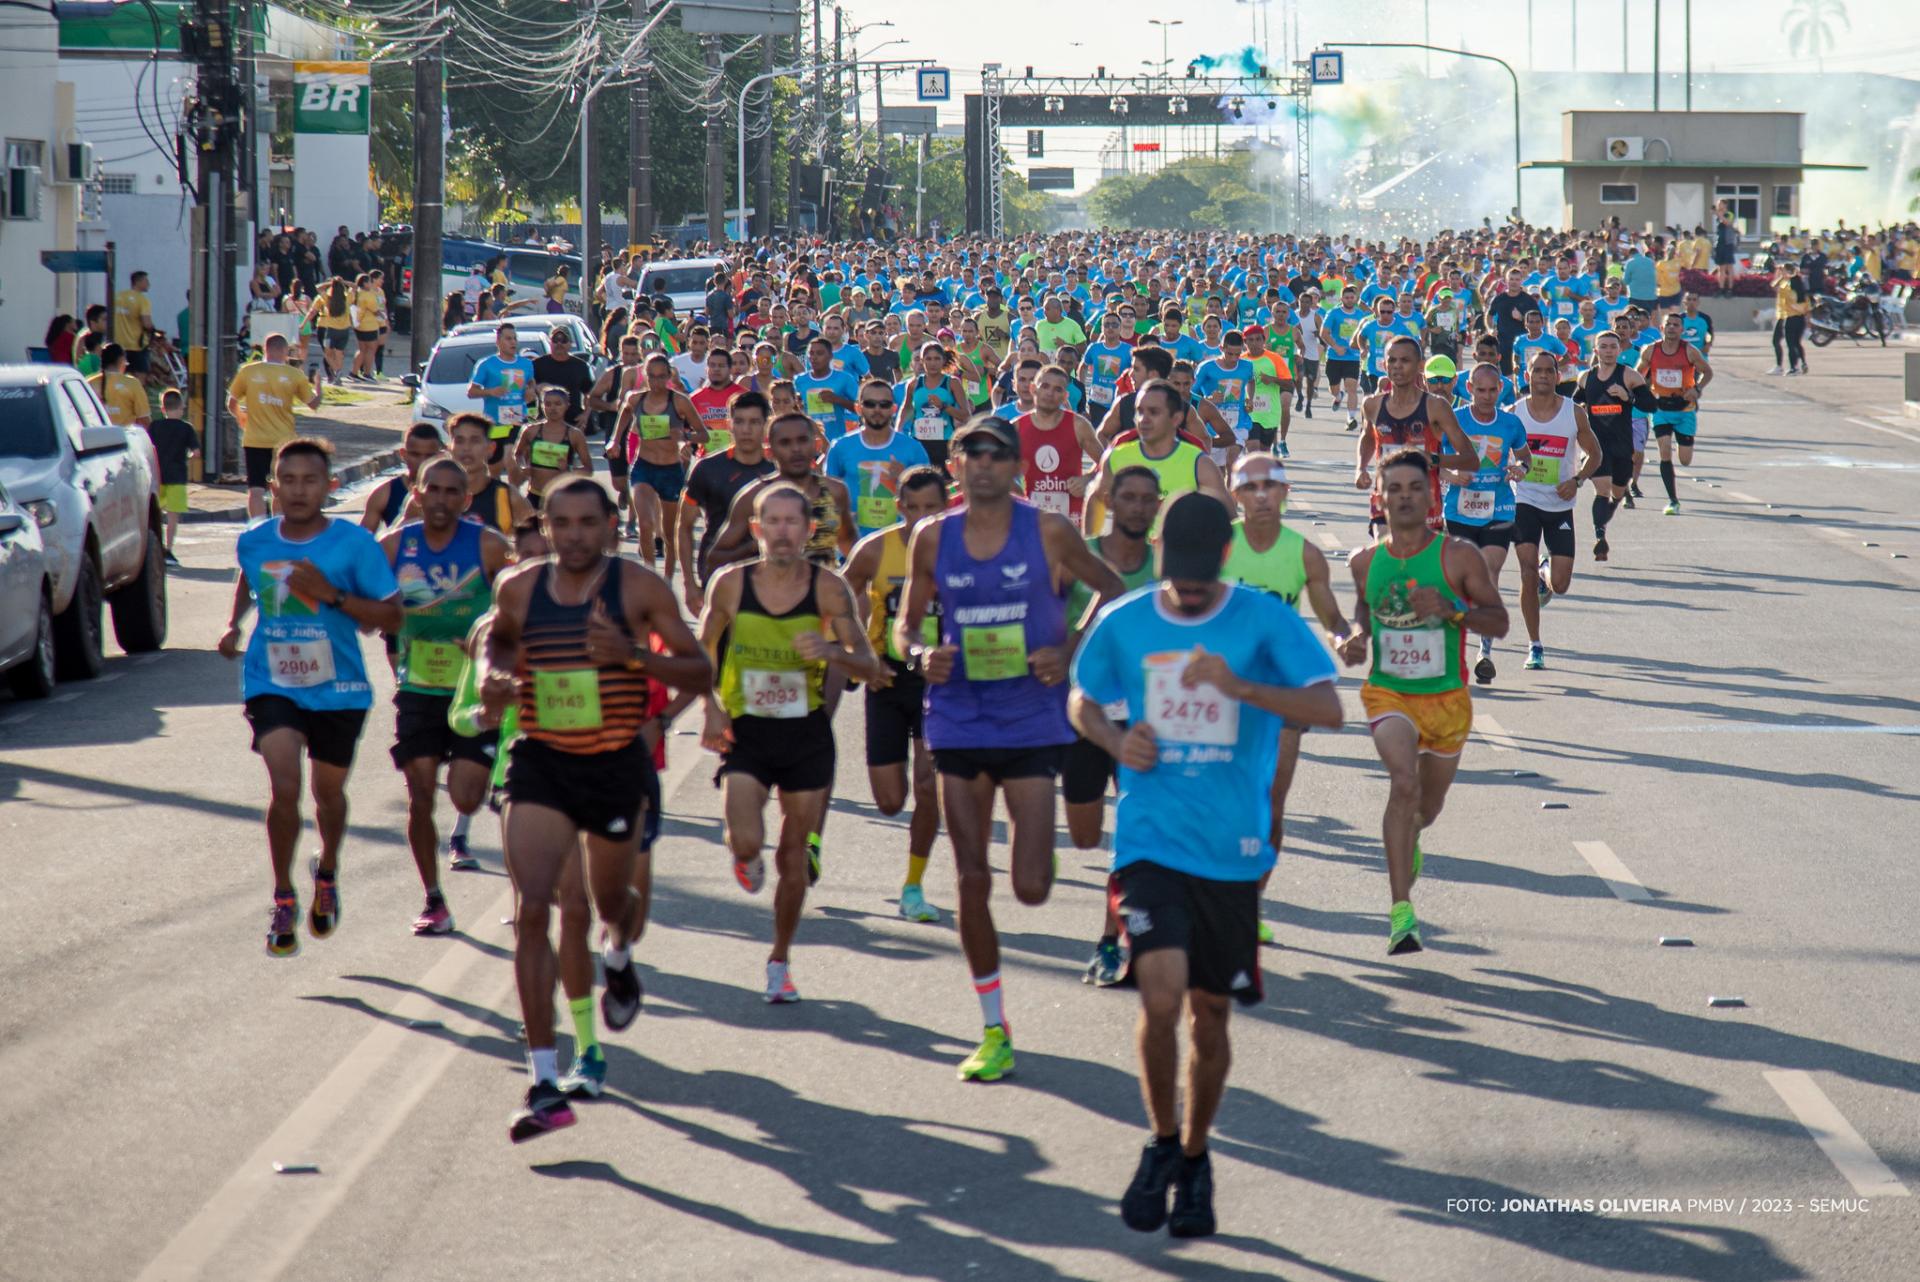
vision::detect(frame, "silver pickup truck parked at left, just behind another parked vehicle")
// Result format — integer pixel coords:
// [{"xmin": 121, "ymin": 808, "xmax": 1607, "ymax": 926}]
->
[{"xmin": 0, "ymin": 365, "xmax": 167, "ymax": 679}]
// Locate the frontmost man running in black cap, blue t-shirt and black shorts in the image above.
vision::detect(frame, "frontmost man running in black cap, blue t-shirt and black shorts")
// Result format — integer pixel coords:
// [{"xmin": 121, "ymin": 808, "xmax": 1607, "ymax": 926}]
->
[{"xmin": 1071, "ymin": 493, "xmax": 1344, "ymax": 1238}]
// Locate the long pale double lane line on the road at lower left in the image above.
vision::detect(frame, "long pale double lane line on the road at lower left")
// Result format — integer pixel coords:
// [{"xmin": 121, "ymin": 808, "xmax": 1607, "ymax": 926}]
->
[{"xmin": 138, "ymin": 736, "xmax": 707, "ymax": 1282}]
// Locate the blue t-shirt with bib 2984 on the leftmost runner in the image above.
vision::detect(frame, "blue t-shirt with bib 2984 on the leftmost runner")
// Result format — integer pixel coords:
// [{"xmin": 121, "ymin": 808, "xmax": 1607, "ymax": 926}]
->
[{"xmin": 234, "ymin": 516, "xmax": 399, "ymax": 712}]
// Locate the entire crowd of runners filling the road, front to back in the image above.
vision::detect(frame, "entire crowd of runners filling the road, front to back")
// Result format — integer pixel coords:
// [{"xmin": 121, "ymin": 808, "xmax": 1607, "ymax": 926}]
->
[{"xmin": 221, "ymin": 226, "xmax": 1713, "ymax": 1236}]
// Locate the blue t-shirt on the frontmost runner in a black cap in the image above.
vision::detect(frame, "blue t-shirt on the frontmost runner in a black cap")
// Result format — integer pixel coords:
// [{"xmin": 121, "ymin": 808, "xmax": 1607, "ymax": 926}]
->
[{"xmin": 1073, "ymin": 583, "xmax": 1334, "ymax": 881}]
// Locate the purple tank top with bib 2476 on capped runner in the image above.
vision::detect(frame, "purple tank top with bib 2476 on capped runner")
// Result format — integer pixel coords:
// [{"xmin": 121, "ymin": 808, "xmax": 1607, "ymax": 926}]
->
[{"xmin": 927, "ymin": 499, "xmax": 1073, "ymax": 748}]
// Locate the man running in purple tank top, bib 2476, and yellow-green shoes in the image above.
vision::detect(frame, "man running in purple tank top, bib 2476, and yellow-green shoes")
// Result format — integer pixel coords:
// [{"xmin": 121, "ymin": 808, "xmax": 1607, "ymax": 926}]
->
[{"xmin": 893, "ymin": 416, "xmax": 1121, "ymax": 1082}]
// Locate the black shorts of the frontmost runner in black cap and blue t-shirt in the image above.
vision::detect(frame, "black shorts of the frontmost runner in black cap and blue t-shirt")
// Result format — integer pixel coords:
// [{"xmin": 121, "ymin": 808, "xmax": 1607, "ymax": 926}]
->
[{"xmin": 1106, "ymin": 862, "xmax": 1267, "ymax": 1006}]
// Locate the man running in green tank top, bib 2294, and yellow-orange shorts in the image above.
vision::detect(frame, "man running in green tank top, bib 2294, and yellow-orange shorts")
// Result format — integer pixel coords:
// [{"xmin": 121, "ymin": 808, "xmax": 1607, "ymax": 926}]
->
[{"xmin": 1340, "ymin": 451, "xmax": 1512, "ymax": 956}]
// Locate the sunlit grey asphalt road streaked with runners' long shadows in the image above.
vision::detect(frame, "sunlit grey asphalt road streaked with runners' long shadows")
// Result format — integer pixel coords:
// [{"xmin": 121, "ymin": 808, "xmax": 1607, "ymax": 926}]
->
[{"xmin": 0, "ymin": 336, "xmax": 1920, "ymax": 1282}]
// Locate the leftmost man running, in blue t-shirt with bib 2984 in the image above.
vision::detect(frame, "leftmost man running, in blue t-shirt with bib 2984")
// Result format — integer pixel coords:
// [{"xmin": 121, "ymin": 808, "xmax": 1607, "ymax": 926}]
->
[{"xmin": 219, "ymin": 436, "xmax": 401, "ymax": 958}]
